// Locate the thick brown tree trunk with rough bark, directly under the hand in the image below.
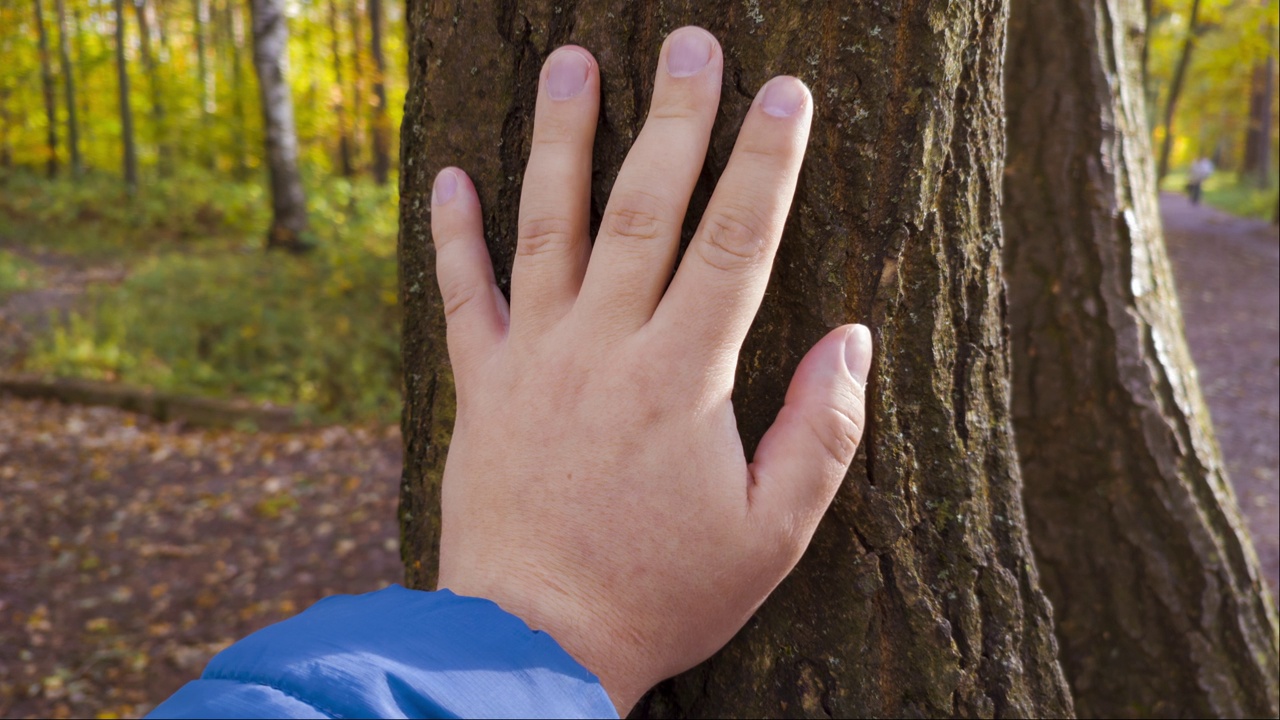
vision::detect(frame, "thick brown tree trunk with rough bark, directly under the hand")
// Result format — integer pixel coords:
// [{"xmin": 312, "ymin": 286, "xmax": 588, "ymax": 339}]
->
[{"xmin": 399, "ymin": 0, "xmax": 1071, "ymax": 717}]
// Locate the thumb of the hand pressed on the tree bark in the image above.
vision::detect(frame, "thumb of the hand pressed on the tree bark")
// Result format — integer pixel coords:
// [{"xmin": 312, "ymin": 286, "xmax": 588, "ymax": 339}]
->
[{"xmin": 751, "ymin": 325, "xmax": 872, "ymax": 532}]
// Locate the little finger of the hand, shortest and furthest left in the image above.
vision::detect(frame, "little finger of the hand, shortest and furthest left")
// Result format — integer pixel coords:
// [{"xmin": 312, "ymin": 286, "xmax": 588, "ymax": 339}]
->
[{"xmin": 431, "ymin": 168, "xmax": 509, "ymax": 372}]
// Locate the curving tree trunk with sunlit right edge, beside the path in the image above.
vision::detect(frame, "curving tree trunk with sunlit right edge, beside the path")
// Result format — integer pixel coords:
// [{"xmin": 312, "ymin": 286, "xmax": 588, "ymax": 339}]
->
[{"xmin": 1004, "ymin": 0, "xmax": 1280, "ymax": 717}]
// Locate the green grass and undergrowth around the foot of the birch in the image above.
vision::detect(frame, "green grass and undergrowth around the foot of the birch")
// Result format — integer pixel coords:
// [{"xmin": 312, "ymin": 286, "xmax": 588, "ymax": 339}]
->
[{"xmin": 0, "ymin": 170, "xmax": 401, "ymax": 421}]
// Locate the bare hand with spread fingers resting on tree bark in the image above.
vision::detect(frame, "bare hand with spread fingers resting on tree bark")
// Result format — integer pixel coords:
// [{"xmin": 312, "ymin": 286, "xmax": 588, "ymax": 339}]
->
[{"xmin": 431, "ymin": 27, "xmax": 872, "ymax": 716}]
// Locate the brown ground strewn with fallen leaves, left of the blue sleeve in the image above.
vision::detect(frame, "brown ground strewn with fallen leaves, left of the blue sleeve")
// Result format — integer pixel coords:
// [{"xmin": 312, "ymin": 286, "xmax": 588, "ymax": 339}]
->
[{"xmin": 0, "ymin": 397, "xmax": 402, "ymax": 717}]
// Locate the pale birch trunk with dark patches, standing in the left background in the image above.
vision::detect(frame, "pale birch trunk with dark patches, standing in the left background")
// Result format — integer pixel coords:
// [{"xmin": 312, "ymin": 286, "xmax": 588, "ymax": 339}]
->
[{"xmin": 252, "ymin": 0, "xmax": 307, "ymax": 250}]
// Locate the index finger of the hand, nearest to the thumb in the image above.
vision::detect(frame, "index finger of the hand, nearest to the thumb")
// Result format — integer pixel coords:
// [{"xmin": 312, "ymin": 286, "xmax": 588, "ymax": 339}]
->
[{"xmin": 653, "ymin": 77, "xmax": 813, "ymax": 352}]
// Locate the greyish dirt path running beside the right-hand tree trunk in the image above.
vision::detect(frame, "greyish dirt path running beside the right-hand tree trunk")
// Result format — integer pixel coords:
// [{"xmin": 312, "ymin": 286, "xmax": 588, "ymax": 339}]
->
[{"xmin": 1160, "ymin": 193, "xmax": 1280, "ymax": 592}]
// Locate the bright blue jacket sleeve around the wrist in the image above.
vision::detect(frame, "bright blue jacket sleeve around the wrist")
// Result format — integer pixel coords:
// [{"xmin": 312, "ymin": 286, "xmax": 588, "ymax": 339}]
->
[{"xmin": 148, "ymin": 585, "xmax": 617, "ymax": 717}]
